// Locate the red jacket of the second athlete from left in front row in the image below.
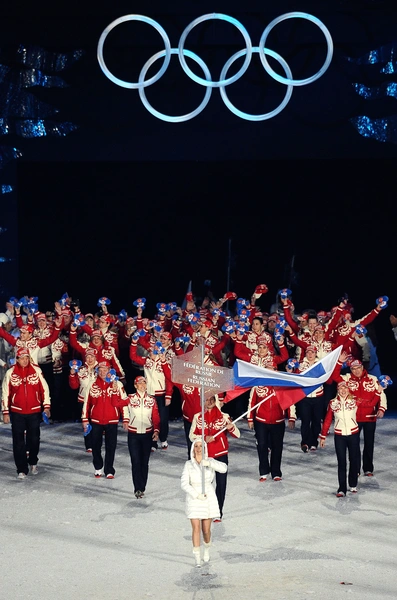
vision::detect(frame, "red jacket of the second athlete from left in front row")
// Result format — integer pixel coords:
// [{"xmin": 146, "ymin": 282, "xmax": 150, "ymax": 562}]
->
[{"xmin": 81, "ymin": 377, "xmax": 127, "ymax": 425}]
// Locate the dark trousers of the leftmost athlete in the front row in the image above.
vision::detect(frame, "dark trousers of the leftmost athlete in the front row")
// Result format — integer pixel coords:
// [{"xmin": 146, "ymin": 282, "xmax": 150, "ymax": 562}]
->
[{"xmin": 10, "ymin": 412, "xmax": 41, "ymax": 475}]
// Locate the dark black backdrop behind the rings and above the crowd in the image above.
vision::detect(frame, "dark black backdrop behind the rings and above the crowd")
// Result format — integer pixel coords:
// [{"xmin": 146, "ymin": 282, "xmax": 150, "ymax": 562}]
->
[{"xmin": 0, "ymin": 0, "xmax": 397, "ymax": 404}]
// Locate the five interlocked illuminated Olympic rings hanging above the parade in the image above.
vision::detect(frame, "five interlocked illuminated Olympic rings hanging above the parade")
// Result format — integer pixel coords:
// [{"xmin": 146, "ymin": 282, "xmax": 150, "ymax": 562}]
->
[{"xmin": 97, "ymin": 12, "xmax": 333, "ymax": 123}]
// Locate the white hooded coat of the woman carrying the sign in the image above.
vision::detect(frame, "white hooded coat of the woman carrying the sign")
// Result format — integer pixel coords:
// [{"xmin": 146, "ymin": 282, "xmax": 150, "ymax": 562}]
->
[{"xmin": 181, "ymin": 440, "xmax": 227, "ymax": 519}]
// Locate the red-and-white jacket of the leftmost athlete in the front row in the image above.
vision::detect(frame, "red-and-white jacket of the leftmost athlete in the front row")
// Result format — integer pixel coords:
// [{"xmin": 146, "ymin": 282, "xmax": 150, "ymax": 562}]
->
[{"xmin": 2, "ymin": 363, "xmax": 51, "ymax": 415}]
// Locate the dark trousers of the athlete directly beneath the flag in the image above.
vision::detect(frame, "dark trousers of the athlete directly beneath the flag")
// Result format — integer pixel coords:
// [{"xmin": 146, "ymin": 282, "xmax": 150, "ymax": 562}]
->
[{"xmin": 254, "ymin": 419, "xmax": 285, "ymax": 478}]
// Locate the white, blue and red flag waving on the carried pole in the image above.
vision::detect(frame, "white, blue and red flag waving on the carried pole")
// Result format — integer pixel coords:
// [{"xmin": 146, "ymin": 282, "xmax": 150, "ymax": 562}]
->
[{"xmin": 225, "ymin": 346, "xmax": 342, "ymax": 410}]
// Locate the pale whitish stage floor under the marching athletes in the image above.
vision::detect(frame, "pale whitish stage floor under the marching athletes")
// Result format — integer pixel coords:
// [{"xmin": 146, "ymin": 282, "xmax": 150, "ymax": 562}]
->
[{"xmin": 0, "ymin": 416, "xmax": 397, "ymax": 600}]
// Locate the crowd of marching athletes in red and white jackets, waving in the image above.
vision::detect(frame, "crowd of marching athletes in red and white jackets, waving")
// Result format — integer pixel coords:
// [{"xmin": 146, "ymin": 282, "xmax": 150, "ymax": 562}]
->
[{"xmin": 0, "ymin": 284, "xmax": 397, "ymax": 500}]
